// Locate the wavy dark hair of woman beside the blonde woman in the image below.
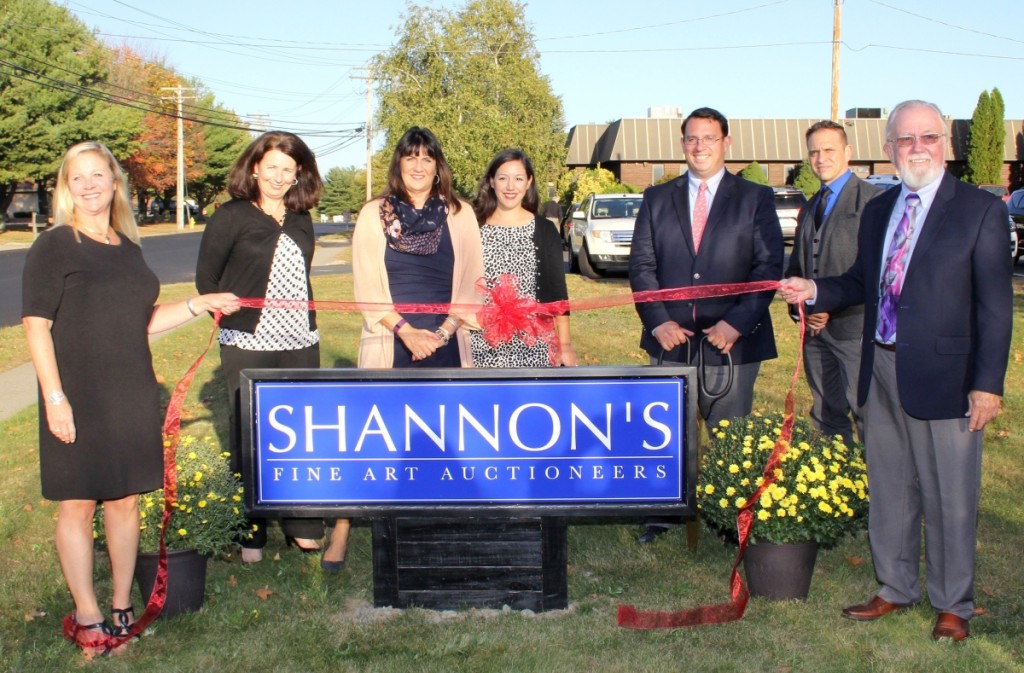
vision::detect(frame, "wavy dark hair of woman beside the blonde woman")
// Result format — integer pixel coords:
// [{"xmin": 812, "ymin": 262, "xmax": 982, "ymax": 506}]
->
[{"xmin": 227, "ymin": 131, "xmax": 324, "ymax": 213}]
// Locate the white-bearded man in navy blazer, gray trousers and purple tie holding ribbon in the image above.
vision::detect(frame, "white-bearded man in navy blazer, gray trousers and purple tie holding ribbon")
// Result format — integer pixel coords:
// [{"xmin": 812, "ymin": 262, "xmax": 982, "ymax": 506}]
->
[{"xmin": 782, "ymin": 100, "xmax": 1013, "ymax": 641}]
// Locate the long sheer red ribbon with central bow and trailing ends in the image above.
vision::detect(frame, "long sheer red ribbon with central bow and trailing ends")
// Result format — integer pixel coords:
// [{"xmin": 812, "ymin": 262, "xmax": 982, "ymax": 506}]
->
[{"xmin": 130, "ymin": 275, "xmax": 790, "ymax": 635}]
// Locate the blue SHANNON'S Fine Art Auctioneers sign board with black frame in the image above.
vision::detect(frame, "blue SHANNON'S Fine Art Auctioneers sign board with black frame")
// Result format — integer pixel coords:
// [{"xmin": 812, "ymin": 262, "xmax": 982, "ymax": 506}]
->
[{"xmin": 243, "ymin": 368, "xmax": 695, "ymax": 512}]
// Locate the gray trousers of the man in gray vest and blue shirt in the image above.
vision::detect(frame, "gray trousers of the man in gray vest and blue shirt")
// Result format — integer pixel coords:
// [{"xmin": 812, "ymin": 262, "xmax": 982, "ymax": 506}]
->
[{"xmin": 804, "ymin": 329, "xmax": 864, "ymax": 446}]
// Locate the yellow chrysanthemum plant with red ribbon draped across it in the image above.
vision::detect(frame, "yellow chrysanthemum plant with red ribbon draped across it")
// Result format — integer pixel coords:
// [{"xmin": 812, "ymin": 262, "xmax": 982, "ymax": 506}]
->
[{"xmin": 697, "ymin": 414, "xmax": 867, "ymax": 546}]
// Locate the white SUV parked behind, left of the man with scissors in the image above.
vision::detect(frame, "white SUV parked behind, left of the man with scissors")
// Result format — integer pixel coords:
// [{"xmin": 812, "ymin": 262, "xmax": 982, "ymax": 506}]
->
[{"xmin": 565, "ymin": 194, "xmax": 643, "ymax": 279}]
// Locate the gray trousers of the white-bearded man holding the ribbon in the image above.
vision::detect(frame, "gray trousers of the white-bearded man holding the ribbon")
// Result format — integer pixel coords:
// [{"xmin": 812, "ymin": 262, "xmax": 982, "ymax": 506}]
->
[{"xmin": 863, "ymin": 348, "xmax": 982, "ymax": 619}]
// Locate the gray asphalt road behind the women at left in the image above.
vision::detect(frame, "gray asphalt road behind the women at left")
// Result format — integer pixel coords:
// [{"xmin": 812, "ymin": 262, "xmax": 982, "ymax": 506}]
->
[{"xmin": 0, "ymin": 223, "xmax": 351, "ymax": 327}]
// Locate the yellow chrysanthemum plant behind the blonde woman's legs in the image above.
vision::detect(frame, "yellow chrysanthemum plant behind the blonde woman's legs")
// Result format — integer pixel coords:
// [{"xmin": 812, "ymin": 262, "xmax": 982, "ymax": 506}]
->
[{"xmin": 94, "ymin": 435, "xmax": 247, "ymax": 556}]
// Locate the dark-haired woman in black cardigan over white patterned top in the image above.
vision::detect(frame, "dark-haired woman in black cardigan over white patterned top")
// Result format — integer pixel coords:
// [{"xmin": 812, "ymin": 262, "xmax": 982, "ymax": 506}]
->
[{"xmin": 196, "ymin": 131, "xmax": 348, "ymax": 572}]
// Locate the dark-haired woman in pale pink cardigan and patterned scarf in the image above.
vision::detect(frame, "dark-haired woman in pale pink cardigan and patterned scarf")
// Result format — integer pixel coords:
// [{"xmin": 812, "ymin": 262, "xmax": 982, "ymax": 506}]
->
[{"xmin": 352, "ymin": 126, "xmax": 483, "ymax": 368}]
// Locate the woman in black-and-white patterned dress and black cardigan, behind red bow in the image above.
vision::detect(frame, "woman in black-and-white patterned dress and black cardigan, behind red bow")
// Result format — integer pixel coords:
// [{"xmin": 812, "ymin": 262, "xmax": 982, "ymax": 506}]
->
[{"xmin": 470, "ymin": 150, "xmax": 577, "ymax": 368}]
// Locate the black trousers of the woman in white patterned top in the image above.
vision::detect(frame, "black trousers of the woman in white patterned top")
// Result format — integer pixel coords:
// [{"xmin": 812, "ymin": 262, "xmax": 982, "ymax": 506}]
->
[{"xmin": 220, "ymin": 344, "xmax": 324, "ymax": 549}]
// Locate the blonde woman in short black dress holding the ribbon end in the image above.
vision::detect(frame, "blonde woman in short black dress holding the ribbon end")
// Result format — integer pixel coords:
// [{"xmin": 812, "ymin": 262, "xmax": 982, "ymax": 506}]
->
[{"xmin": 22, "ymin": 141, "xmax": 239, "ymax": 654}]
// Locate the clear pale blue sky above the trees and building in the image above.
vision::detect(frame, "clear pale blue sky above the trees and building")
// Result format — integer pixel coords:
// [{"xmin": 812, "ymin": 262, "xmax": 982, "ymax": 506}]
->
[{"xmin": 64, "ymin": 0, "xmax": 1024, "ymax": 173}]
